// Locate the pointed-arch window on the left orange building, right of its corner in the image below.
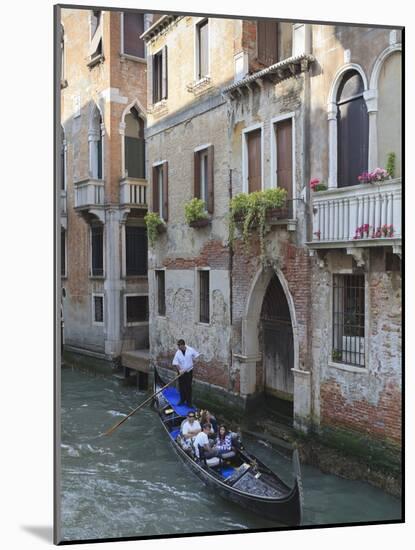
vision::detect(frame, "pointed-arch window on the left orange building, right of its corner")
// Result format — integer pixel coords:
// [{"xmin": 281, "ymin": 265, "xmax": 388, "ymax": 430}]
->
[{"xmin": 125, "ymin": 107, "xmax": 145, "ymax": 179}]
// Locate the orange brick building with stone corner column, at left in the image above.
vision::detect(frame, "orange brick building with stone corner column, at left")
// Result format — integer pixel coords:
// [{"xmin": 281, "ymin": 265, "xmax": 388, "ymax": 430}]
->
[{"xmin": 60, "ymin": 8, "xmax": 161, "ymax": 360}]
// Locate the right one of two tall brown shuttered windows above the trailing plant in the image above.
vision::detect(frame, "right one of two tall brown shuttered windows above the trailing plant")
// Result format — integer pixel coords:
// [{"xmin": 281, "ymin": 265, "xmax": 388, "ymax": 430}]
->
[{"xmin": 274, "ymin": 118, "xmax": 293, "ymax": 199}]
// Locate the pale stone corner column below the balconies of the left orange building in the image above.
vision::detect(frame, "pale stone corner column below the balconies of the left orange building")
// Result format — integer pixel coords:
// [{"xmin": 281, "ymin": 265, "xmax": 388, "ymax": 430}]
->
[{"xmin": 104, "ymin": 208, "xmax": 121, "ymax": 359}]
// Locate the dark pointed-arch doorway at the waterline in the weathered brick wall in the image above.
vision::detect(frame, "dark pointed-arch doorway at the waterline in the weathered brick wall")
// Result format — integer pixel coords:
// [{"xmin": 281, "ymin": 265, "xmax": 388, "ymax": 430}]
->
[{"xmin": 260, "ymin": 274, "xmax": 294, "ymax": 406}]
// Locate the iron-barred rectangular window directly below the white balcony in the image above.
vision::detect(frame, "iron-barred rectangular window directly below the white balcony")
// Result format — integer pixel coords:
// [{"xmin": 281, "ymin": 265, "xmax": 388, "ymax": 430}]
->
[{"xmin": 332, "ymin": 275, "xmax": 365, "ymax": 367}]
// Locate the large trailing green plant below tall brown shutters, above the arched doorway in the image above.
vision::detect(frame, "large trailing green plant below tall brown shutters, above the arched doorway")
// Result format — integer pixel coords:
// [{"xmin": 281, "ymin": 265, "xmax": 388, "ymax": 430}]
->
[{"xmin": 229, "ymin": 188, "xmax": 287, "ymax": 262}]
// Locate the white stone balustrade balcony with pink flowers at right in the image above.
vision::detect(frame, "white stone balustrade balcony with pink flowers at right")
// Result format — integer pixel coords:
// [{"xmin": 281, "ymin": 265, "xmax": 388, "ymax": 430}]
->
[{"xmin": 307, "ymin": 178, "xmax": 402, "ymax": 253}]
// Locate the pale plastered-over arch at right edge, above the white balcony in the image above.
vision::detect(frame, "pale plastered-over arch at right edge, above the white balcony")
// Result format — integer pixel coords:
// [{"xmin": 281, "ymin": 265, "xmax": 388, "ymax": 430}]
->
[{"xmin": 377, "ymin": 52, "xmax": 402, "ymax": 177}]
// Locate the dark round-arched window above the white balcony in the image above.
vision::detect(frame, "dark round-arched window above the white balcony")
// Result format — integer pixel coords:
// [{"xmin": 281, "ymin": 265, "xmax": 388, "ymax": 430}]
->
[{"xmin": 336, "ymin": 70, "xmax": 369, "ymax": 187}]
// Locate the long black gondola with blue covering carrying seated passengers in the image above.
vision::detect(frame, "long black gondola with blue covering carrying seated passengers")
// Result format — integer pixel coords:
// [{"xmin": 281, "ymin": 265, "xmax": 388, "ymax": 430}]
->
[{"xmin": 154, "ymin": 369, "xmax": 303, "ymax": 526}]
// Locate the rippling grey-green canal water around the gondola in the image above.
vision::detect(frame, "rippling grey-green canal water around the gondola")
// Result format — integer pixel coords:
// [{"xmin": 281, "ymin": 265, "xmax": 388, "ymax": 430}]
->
[{"xmin": 61, "ymin": 367, "xmax": 401, "ymax": 541}]
